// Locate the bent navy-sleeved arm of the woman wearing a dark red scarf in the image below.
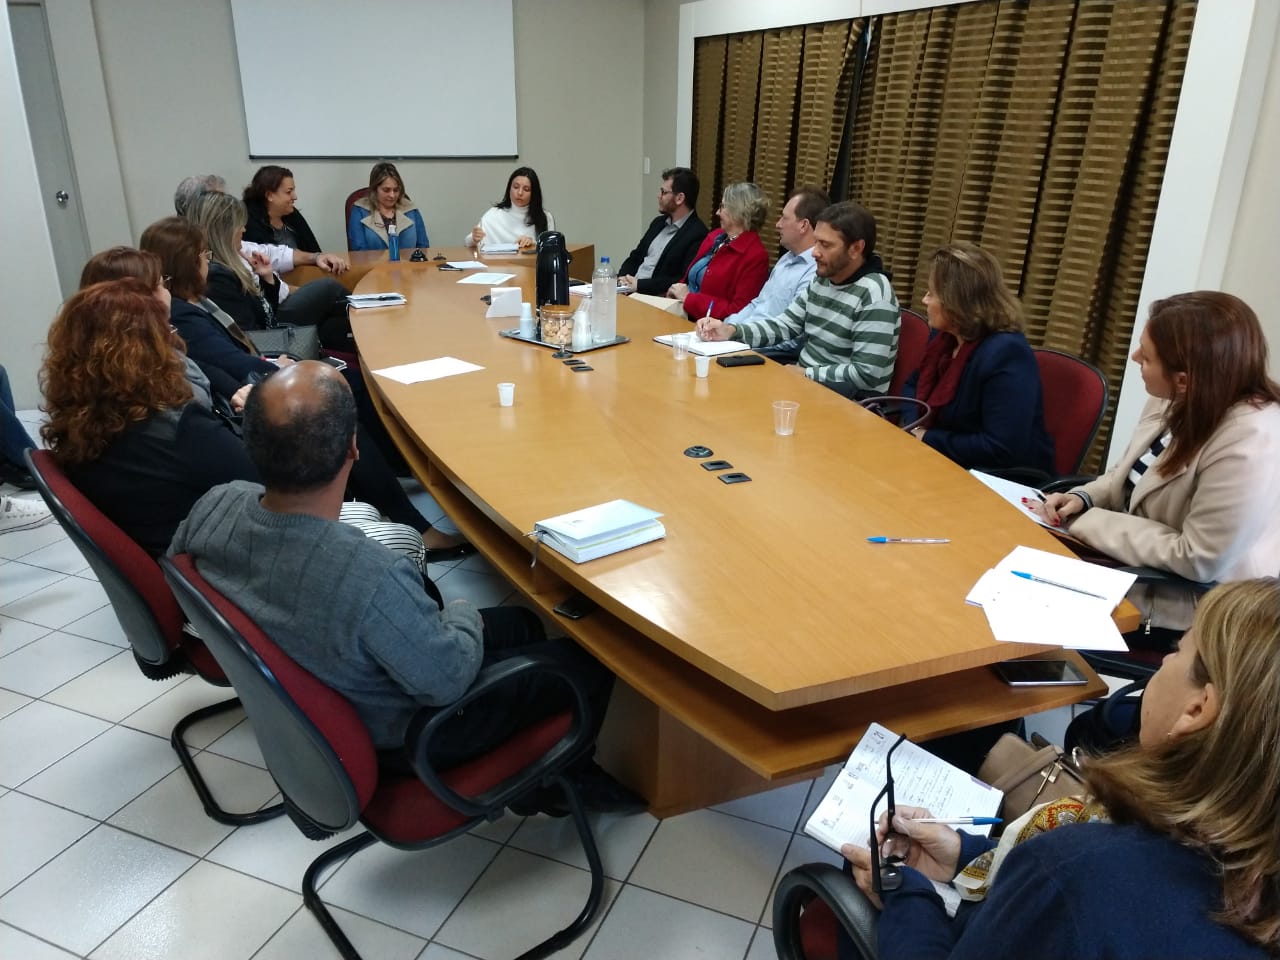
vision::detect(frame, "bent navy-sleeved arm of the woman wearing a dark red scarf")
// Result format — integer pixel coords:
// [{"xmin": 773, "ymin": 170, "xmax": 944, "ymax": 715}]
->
[{"xmin": 923, "ymin": 352, "xmax": 1039, "ymax": 468}]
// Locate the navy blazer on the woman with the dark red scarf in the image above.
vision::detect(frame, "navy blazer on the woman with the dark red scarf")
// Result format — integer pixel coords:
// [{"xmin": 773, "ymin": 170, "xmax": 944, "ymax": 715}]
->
[{"xmin": 902, "ymin": 332, "xmax": 1053, "ymax": 476}]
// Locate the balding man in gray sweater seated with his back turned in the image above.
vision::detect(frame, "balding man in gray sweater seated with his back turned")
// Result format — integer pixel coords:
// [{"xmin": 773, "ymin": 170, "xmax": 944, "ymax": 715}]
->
[{"xmin": 169, "ymin": 361, "xmax": 635, "ymax": 808}]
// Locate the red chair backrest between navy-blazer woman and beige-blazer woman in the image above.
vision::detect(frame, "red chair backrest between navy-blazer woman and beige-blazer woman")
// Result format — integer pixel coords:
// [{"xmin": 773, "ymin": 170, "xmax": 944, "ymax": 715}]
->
[{"xmin": 1032, "ymin": 347, "xmax": 1111, "ymax": 476}]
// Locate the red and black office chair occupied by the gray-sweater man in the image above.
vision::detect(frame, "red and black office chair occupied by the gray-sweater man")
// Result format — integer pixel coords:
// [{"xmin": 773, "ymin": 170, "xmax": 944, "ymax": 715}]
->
[{"xmin": 161, "ymin": 554, "xmax": 604, "ymax": 960}]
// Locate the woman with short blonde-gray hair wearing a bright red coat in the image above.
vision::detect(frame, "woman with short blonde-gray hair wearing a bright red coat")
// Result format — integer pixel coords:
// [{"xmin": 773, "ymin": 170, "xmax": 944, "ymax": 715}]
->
[{"xmin": 667, "ymin": 183, "xmax": 769, "ymax": 320}]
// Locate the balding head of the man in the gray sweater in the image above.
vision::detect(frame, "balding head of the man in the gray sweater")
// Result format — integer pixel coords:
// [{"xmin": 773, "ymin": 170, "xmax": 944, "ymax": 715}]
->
[{"xmin": 244, "ymin": 360, "xmax": 356, "ymax": 493}]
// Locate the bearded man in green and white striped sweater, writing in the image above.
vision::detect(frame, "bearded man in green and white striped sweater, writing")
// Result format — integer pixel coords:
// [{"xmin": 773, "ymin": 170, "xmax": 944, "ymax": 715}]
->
[{"xmin": 698, "ymin": 201, "xmax": 901, "ymax": 397}]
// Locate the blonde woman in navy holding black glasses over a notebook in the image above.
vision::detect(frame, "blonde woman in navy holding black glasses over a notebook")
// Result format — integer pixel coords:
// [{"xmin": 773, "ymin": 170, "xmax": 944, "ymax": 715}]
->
[{"xmin": 842, "ymin": 577, "xmax": 1280, "ymax": 960}]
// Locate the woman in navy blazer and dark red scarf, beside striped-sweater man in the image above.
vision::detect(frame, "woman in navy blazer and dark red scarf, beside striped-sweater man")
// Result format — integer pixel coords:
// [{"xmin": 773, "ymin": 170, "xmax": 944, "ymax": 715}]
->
[{"xmin": 906, "ymin": 243, "xmax": 1053, "ymax": 475}]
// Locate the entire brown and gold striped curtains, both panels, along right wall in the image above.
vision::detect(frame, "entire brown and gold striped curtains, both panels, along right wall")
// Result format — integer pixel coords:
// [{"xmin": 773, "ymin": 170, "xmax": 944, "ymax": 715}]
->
[{"xmin": 694, "ymin": 0, "xmax": 1196, "ymax": 468}]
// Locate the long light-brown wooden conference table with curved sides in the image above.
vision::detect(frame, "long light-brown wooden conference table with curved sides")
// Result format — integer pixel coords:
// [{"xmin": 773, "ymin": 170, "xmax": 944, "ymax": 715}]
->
[{"xmin": 352, "ymin": 252, "xmax": 1138, "ymax": 817}]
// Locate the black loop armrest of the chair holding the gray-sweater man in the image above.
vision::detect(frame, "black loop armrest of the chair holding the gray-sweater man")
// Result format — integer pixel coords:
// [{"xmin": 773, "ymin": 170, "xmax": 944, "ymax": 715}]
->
[{"xmin": 404, "ymin": 657, "xmax": 594, "ymax": 817}]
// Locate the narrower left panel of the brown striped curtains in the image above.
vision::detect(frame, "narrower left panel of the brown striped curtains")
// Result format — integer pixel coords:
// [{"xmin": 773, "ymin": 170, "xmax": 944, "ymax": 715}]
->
[{"xmin": 692, "ymin": 20, "xmax": 863, "ymax": 252}]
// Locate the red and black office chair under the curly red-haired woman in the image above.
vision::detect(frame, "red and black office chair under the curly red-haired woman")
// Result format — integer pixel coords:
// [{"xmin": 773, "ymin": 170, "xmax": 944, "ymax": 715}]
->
[{"xmin": 27, "ymin": 449, "xmax": 284, "ymax": 826}]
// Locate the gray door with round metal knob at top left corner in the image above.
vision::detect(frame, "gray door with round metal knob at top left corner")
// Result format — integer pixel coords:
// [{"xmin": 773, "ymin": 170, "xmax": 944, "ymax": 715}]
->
[{"xmin": 9, "ymin": 3, "xmax": 90, "ymax": 297}]
